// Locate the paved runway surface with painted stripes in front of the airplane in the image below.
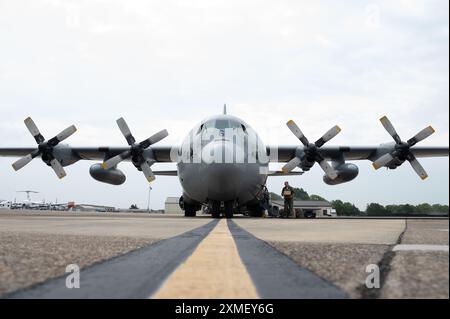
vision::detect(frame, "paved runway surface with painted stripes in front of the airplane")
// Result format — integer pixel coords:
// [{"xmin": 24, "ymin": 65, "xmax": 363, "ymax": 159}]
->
[{"xmin": 0, "ymin": 211, "xmax": 449, "ymax": 299}]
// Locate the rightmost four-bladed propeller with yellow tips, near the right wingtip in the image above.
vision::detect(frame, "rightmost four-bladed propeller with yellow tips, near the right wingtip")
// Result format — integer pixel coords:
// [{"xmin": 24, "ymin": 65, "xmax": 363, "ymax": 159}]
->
[{"xmin": 372, "ymin": 116, "xmax": 435, "ymax": 179}]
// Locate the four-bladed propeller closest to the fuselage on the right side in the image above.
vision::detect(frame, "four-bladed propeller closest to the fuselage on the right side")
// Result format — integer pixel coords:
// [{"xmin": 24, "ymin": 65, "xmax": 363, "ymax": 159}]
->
[{"xmin": 282, "ymin": 120, "xmax": 341, "ymax": 179}]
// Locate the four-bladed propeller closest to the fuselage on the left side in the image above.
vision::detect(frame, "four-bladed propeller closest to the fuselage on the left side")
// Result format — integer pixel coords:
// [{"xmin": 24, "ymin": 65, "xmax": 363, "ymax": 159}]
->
[{"xmin": 102, "ymin": 118, "xmax": 169, "ymax": 182}]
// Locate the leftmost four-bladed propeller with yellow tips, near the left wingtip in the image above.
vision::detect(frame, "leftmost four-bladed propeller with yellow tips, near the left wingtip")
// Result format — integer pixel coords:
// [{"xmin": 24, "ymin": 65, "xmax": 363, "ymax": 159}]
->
[{"xmin": 12, "ymin": 117, "xmax": 77, "ymax": 178}]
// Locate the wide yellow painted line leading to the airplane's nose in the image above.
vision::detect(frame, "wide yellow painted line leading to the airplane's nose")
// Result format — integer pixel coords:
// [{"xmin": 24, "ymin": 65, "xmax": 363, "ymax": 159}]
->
[{"xmin": 151, "ymin": 220, "xmax": 259, "ymax": 299}]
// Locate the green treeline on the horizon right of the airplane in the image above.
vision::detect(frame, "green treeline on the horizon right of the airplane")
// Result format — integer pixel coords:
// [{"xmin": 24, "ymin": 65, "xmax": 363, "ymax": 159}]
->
[{"xmin": 270, "ymin": 187, "xmax": 449, "ymax": 216}]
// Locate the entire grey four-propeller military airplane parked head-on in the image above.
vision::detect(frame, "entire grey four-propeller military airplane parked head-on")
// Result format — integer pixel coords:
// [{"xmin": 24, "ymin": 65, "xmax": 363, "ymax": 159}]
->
[{"xmin": 0, "ymin": 106, "xmax": 449, "ymax": 218}]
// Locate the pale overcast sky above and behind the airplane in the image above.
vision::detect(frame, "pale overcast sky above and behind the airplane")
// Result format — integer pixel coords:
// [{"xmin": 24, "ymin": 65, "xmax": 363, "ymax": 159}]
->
[{"xmin": 0, "ymin": 0, "xmax": 449, "ymax": 208}]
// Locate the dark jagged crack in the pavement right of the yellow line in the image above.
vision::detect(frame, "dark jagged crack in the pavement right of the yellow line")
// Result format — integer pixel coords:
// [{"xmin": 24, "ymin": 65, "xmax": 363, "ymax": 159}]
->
[{"xmin": 358, "ymin": 219, "xmax": 408, "ymax": 299}]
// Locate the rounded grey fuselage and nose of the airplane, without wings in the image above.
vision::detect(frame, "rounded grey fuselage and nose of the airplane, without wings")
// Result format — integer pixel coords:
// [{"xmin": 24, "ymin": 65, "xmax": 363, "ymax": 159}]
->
[{"xmin": 178, "ymin": 115, "xmax": 268, "ymax": 206}]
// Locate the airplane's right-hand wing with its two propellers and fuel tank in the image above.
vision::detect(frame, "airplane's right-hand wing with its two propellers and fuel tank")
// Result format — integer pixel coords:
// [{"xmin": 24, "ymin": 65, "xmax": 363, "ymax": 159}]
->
[{"xmin": 267, "ymin": 116, "xmax": 449, "ymax": 185}]
